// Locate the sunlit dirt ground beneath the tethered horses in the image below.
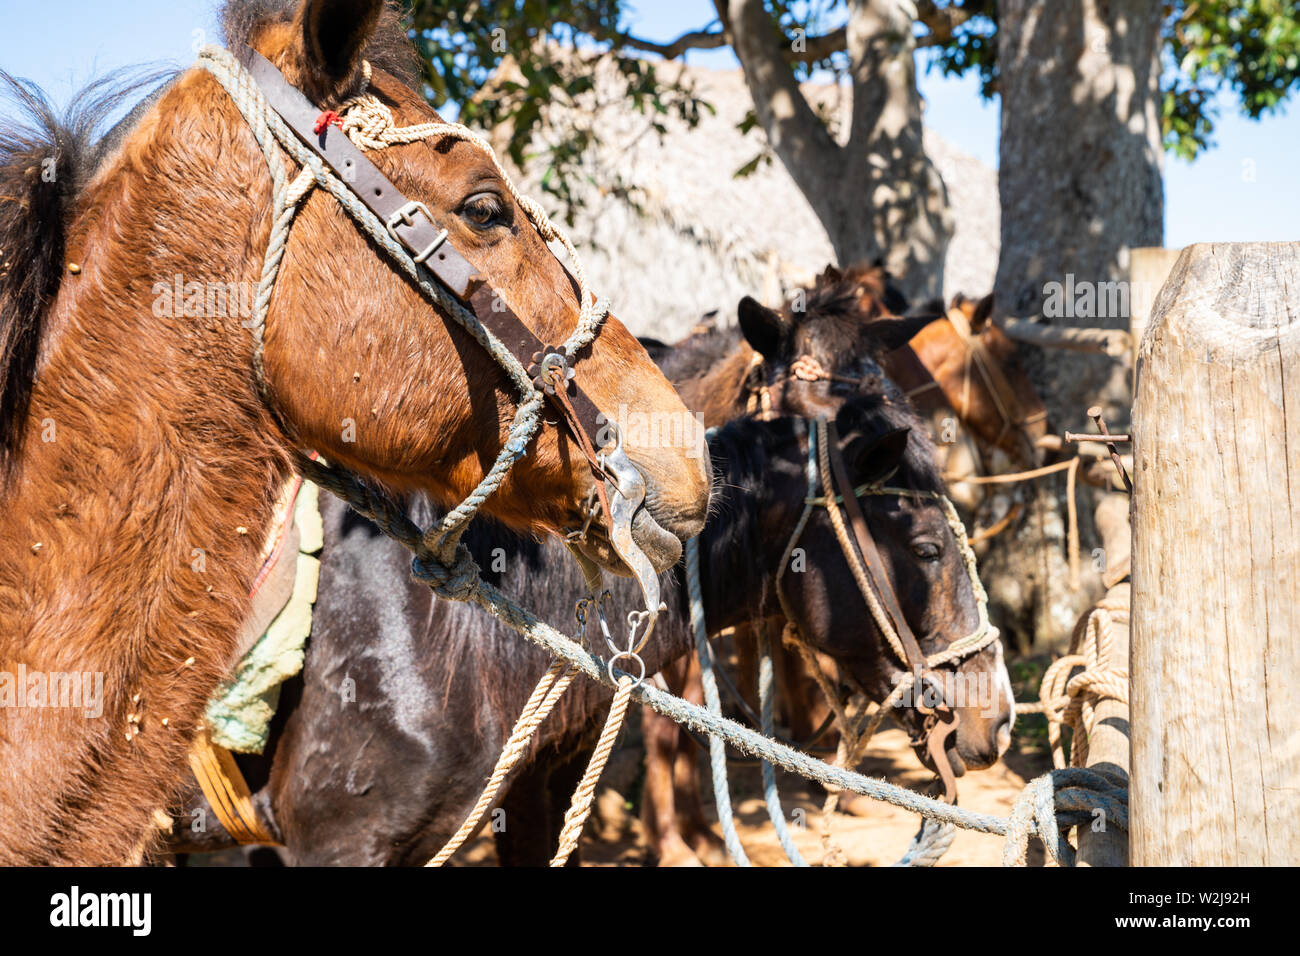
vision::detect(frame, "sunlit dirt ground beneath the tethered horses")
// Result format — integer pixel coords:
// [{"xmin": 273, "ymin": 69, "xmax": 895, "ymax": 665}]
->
[{"xmin": 458, "ymin": 719, "xmax": 1052, "ymax": 866}]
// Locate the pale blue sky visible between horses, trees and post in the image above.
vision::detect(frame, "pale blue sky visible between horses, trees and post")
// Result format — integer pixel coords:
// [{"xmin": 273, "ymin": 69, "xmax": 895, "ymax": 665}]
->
[{"xmin": 0, "ymin": 0, "xmax": 1300, "ymax": 247}]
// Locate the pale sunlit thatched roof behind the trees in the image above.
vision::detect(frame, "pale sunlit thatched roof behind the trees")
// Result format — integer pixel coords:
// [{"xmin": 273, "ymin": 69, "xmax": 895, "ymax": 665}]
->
[{"xmin": 491, "ymin": 55, "xmax": 998, "ymax": 341}]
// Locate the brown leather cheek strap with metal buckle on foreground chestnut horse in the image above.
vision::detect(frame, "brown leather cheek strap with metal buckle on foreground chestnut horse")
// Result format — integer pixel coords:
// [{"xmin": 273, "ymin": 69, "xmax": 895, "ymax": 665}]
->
[{"xmin": 234, "ymin": 47, "xmax": 603, "ymax": 457}]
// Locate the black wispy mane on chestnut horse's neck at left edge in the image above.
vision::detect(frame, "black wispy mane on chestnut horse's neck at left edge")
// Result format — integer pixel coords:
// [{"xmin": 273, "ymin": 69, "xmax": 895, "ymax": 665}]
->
[{"xmin": 0, "ymin": 72, "xmax": 160, "ymax": 477}]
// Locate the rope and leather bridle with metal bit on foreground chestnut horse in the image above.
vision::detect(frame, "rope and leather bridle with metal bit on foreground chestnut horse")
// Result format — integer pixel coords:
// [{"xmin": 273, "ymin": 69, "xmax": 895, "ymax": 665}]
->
[{"xmin": 198, "ymin": 46, "xmax": 662, "ymax": 636}]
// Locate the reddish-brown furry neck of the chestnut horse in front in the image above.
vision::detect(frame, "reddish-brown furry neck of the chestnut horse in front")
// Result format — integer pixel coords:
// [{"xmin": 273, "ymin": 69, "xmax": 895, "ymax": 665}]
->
[{"xmin": 0, "ymin": 76, "xmax": 287, "ymax": 864}]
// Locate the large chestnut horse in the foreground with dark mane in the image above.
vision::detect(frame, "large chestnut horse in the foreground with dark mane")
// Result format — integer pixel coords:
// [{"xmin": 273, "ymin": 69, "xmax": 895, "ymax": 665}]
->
[{"xmin": 0, "ymin": 0, "xmax": 709, "ymax": 865}]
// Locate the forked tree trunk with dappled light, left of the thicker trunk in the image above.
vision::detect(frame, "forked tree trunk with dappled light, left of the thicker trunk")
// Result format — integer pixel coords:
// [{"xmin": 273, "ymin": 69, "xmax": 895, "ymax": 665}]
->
[{"xmin": 716, "ymin": 0, "xmax": 952, "ymax": 299}]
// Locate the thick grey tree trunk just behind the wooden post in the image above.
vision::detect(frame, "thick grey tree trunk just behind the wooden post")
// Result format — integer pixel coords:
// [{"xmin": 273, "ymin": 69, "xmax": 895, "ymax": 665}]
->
[{"xmin": 993, "ymin": 0, "xmax": 1164, "ymax": 645}]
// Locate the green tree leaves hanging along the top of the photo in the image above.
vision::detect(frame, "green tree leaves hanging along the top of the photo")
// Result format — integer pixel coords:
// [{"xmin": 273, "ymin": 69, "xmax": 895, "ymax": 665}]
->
[{"xmin": 411, "ymin": 0, "xmax": 1300, "ymax": 192}]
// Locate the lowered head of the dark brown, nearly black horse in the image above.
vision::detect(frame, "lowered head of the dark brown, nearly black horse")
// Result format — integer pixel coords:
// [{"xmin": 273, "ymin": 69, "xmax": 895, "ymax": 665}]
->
[{"xmin": 711, "ymin": 390, "xmax": 1015, "ymax": 775}]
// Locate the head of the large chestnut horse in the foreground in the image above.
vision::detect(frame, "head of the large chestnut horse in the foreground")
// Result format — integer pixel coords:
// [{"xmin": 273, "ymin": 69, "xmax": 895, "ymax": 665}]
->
[{"xmin": 223, "ymin": 0, "xmax": 707, "ymax": 570}]
